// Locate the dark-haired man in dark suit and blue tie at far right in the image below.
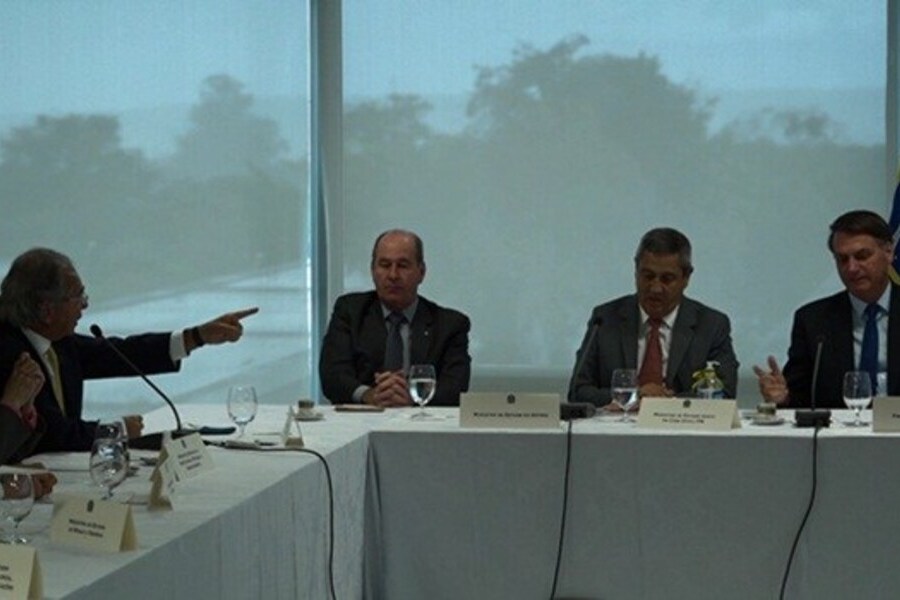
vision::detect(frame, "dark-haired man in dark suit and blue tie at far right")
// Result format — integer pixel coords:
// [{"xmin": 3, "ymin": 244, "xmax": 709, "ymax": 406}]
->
[{"xmin": 753, "ymin": 210, "xmax": 900, "ymax": 408}]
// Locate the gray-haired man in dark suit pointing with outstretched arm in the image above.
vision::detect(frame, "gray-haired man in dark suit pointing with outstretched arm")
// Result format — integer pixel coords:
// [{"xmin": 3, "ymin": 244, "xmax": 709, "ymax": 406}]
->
[{"xmin": 0, "ymin": 248, "xmax": 258, "ymax": 452}]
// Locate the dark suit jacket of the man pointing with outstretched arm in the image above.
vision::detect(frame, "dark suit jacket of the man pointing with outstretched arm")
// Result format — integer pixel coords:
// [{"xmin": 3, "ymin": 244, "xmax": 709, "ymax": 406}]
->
[{"xmin": 0, "ymin": 323, "xmax": 180, "ymax": 452}]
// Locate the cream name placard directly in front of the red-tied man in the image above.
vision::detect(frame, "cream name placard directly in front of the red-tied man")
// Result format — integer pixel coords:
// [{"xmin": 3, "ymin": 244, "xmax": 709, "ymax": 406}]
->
[{"xmin": 637, "ymin": 398, "xmax": 741, "ymax": 431}]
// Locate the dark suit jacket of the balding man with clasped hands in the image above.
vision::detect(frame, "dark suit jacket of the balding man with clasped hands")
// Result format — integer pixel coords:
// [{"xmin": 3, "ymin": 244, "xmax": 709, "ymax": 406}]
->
[{"xmin": 319, "ymin": 291, "xmax": 471, "ymax": 406}]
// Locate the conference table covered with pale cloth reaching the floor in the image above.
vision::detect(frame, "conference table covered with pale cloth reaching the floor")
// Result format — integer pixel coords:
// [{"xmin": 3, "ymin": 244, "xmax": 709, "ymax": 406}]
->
[{"xmin": 14, "ymin": 406, "xmax": 900, "ymax": 599}]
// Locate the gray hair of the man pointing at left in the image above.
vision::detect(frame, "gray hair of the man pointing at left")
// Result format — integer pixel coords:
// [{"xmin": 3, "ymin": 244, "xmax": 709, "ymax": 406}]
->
[{"xmin": 0, "ymin": 248, "xmax": 75, "ymax": 327}]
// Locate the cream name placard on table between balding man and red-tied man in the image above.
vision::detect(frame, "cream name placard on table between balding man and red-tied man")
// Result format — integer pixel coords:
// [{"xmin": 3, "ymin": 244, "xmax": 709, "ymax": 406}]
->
[{"xmin": 459, "ymin": 393, "xmax": 559, "ymax": 429}]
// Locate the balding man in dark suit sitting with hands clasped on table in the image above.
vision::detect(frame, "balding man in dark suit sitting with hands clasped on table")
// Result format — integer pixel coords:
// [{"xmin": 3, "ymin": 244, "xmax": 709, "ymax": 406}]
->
[{"xmin": 319, "ymin": 230, "xmax": 471, "ymax": 407}]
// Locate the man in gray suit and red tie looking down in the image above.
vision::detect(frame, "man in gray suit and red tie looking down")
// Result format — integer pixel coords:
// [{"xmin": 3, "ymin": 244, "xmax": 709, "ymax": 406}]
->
[{"xmin": 569, "ymin": 228, "xmax": 738, "ymax": 406}]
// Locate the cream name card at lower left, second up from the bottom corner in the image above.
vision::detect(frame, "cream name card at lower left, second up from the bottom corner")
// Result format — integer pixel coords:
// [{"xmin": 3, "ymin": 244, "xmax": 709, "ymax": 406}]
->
[{"xmin": 50, "ymin": 496, "xmax": 137, "ymax": 552}]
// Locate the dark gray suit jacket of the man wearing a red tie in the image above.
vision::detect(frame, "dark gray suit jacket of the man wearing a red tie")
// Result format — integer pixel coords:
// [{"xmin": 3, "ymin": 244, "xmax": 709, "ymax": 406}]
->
[{"xmin": 569, "ymin": 294, "xmax": 738, "ymax": 406}]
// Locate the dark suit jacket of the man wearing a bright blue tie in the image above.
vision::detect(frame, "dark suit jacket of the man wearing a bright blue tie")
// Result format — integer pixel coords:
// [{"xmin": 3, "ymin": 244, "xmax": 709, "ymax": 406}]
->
[{"xmin": 784, "ymin": 285, "xmax": 900, "ymax": 408}]
